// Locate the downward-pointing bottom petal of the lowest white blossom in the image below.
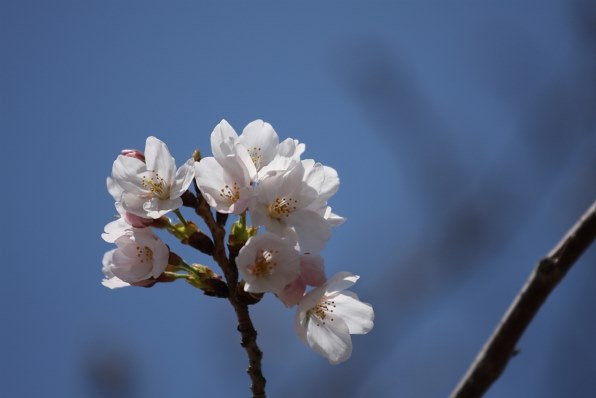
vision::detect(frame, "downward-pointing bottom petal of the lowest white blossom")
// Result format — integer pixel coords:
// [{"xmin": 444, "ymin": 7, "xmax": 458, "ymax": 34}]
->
[{"xmin": 306, "ymin": 317, "xmax": 352, "ymax": 365}]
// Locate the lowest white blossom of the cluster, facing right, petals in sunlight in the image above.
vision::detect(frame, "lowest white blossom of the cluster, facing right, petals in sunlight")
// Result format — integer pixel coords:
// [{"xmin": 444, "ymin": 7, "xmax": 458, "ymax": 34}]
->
[{"xmin": 296, "ymin": 272, "xmax": 374, "ymax": 365}]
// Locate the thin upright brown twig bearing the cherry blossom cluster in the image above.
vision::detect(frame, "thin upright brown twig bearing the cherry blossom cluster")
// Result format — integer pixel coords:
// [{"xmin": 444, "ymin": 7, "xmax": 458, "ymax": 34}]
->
[{"xmin": 195, "ymin": 188, "xmax": 267, "ymax": 398}]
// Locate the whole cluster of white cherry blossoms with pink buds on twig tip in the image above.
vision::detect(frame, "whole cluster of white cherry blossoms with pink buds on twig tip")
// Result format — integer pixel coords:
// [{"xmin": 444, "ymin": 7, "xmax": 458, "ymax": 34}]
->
[{"xmin": 102, "ymin": 120, "xmax": 374, "ymax": 364}]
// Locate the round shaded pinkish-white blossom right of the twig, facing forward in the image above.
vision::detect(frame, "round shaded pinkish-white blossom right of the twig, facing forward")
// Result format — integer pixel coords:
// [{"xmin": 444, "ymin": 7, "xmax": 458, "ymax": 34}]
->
[{"xmin": 236, "ymin": 232, "xmax": 300, "ymax": 293}]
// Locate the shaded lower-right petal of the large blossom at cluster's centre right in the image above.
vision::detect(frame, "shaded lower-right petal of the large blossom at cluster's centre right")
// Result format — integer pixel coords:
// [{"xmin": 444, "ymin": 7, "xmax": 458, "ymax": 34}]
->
[{"xmin": 287, "ymin": 210, "xmax": 331, "ymax": 254}]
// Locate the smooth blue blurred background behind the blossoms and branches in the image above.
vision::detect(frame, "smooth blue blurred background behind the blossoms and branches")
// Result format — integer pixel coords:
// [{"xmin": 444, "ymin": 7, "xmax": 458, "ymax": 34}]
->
[{"xmin": 0, "ymin": 0, "xmax": 596, "ymax": 398}]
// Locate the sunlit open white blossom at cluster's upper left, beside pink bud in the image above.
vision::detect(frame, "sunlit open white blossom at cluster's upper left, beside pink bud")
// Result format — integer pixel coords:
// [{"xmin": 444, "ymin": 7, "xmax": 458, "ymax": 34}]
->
[{"xmin": 108, "ymin": 137, "xmax": 194, "ymax": 219}]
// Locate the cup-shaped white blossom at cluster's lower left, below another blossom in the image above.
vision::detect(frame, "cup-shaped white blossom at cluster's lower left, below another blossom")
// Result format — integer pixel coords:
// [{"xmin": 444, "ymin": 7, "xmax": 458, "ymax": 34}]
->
[{"xmin": 103, "ymin": 228, "xmax": 170, "ymax": 287}]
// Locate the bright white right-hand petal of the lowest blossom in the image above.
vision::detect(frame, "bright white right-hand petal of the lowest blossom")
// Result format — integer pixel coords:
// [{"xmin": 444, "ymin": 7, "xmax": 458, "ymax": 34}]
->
[{"xmin": 333, "ymin": 291, "xmax": 375, "ymax": 334}]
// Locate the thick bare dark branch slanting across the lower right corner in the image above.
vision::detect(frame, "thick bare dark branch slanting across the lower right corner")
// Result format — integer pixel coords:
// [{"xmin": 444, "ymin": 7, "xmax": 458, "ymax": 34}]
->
[{"xmin": 451, "ymin": 202, "xmax": 596, "ymax": 398}]
